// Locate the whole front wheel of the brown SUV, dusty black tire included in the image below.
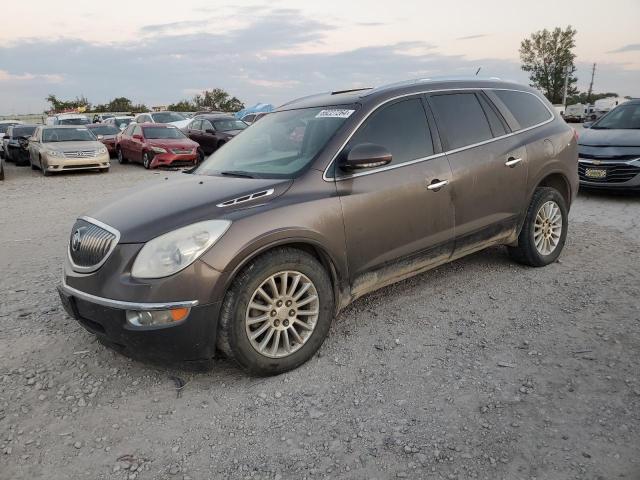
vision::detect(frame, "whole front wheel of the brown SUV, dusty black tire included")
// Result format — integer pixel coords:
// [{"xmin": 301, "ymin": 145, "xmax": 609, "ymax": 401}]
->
[{"xmin": 217, "ymin": 248, "xmax": 334, "ymax": 375}]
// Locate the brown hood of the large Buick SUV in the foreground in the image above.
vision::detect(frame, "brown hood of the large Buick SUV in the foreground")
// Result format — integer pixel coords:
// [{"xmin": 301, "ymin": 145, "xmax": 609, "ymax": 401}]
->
[{"xmin": 87, "ymin": 174, "xmax": 292, "ymax": 243}]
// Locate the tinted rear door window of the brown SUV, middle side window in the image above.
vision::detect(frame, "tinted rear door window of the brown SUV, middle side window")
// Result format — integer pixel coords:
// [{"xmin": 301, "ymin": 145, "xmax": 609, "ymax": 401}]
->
[{"xmin": 430, "ymin": 93, "xmax": 493, "ymax": 149}]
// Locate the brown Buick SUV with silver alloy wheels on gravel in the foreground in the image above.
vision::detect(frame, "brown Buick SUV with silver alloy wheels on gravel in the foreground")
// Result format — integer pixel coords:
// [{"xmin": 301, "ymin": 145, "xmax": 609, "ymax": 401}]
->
[{"xmin": 60, "ymin": 79, "xmax": 578, "ymax": 374}]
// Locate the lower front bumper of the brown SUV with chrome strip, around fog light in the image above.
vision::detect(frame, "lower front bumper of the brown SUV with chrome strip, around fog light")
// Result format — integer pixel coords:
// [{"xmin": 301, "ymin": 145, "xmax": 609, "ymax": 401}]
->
[{"xmin": 58, "ymin": 282, "xmax": 221, "ymax": 361}]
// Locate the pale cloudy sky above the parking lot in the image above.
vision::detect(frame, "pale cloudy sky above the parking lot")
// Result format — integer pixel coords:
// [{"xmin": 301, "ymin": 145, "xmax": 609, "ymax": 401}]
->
[{"xmin": 0, "ymin": 0, "xmax": 640, "ymax": 114}]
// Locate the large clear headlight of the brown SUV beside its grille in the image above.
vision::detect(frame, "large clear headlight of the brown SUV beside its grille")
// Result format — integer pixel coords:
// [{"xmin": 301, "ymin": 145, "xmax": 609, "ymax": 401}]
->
[{"xmin": 131, "ymin": 220, "xmax": 231, "ymax": 278}]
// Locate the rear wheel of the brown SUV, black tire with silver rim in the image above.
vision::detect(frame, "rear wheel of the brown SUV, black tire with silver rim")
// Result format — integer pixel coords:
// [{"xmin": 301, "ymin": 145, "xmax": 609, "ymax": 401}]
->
[{"xmin": 508, "ymin": 187, "xmax": 569, "ymax": 267}]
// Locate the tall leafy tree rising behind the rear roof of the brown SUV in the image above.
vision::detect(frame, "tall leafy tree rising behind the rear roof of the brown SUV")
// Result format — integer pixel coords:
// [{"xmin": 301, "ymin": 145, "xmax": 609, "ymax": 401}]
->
[{"xmin": 520, "ymin": 25, "xmax": 578, "ymax": 103}]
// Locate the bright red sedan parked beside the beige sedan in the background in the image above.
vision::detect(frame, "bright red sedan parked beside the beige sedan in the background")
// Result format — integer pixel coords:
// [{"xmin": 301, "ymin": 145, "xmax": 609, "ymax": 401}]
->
[{"xmin": 116, "ymin": 123, "xmax": 198, "ymax": 168}]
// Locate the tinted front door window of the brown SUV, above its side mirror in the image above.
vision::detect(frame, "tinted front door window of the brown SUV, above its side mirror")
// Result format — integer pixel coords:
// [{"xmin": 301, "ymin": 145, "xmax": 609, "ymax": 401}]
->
[{"xmin": 347, "ymin": 98, "xmax": 433, "ymax": 164}]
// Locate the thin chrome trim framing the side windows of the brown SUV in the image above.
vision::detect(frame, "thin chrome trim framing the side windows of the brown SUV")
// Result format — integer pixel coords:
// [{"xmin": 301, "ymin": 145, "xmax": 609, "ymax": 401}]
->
[{"xmin": 322, "ymin": 87, "xmax": 556, "ymax": 182}]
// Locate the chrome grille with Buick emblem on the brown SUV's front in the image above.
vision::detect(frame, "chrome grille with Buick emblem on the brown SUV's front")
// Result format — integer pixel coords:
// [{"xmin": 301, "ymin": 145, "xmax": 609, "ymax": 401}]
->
[{"xmin": 69, "ymin": 218, "xmax": 119, "ymax": 272}]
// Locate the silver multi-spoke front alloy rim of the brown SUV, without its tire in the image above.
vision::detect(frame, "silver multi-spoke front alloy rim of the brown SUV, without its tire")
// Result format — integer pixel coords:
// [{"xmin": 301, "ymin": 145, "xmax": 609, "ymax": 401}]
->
[{"xmin": 245, "ymin": 270, "xmax": 320, "ymax": 358}]
